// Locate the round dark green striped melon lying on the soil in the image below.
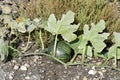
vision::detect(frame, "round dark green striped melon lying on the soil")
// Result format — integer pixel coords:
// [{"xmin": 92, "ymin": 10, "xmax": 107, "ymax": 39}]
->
[{"xmin": 48, "ymin": 41, "xmax": 72, "ymax": 63}]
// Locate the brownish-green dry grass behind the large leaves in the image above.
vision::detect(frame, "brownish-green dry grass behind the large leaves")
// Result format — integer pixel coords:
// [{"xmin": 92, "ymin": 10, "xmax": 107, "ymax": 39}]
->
[{"xmin": 20, "ymin": 0, "xmax": 120, "ymax": 38}]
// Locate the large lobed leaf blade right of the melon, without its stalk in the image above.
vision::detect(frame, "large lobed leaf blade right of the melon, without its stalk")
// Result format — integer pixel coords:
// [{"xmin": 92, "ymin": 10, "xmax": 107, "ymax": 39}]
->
[{"xmin": 80, "ymin": 20, "xmax": 109, "ymax": 52}]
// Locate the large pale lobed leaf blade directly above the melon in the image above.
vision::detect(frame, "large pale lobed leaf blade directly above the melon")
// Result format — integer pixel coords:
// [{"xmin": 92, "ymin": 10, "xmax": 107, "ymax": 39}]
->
[{"xmin": 45, "ymin": 11, "xmax": 79, "ymax": 42}]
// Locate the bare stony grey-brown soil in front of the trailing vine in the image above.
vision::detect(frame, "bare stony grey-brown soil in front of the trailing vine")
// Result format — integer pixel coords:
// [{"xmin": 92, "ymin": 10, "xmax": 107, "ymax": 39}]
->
[{"xmin": 0, "ymin": 56, "xmax": 120, "ymax": 80}]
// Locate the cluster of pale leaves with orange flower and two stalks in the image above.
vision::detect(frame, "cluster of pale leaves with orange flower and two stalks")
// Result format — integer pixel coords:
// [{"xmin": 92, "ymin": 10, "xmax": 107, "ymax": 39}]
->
[{"xmin": 4, "ymin": 16, "xmax": 44, "ymax": 52}]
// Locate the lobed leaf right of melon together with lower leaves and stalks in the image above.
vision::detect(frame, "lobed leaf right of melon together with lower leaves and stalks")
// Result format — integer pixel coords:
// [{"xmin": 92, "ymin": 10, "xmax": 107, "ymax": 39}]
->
[{"xmin": 70, "ymin": 20, "xmax": 109, "ymax": 63}]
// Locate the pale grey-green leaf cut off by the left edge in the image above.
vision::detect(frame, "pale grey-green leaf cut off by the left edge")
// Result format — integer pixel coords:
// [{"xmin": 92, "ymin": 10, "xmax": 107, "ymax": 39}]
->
[{"xmin": 0, "ymin": 38, "xmax": 8, "ymax": 61}]
